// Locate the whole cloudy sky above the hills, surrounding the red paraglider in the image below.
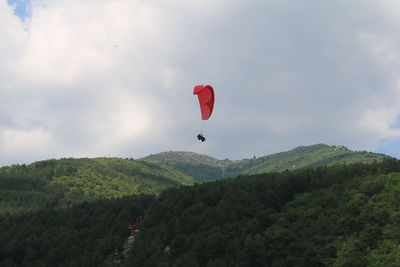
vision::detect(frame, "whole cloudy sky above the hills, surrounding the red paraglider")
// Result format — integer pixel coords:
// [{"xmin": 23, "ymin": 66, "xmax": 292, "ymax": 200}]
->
[{"xmin": 0, "ymin": 0, "xmax": 400, "ymax": 166}]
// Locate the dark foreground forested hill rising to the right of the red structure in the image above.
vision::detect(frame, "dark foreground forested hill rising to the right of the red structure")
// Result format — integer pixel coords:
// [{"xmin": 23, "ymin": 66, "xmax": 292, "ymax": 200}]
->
[{"xmin": 126, "ymin": 158, "xmax": 400, "ymax": 267}]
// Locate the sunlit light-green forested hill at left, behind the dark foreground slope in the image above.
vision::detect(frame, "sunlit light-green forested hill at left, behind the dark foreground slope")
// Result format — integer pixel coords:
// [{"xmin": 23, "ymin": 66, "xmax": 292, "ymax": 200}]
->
[{"xmin": 0, "ymin": 158, "xmax": 195, "ymax": 214}]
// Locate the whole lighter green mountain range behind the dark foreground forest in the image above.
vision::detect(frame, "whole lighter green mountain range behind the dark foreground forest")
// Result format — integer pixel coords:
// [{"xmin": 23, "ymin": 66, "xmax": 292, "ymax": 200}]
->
[{"xmin": 0, "ymin": 144, "xmax": 385, "ymax": 214}]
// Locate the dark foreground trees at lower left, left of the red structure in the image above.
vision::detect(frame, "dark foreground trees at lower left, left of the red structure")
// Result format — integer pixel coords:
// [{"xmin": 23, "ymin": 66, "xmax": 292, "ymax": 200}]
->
[{"xmin": 0, "ymin": 196, "xmax": 154, "ymax": 266}]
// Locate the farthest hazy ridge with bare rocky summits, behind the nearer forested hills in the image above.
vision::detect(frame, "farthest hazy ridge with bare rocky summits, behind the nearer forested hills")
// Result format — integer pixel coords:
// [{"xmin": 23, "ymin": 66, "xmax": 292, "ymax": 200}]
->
[{"xmin": 140, "ymin": 144, "xmax": 385, "ymax": 182}]
